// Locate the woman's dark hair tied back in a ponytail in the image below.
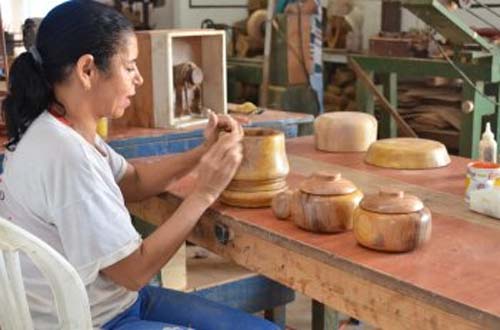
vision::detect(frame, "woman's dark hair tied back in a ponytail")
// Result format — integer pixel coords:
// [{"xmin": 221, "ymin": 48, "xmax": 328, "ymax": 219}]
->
[{"xmin": 2, "ymin": 0, "xmax": 133, "ymax": 151}]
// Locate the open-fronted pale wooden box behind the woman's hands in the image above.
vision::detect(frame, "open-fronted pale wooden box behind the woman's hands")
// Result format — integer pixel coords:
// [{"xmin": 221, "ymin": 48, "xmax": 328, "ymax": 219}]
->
[{"xmin": 113, "ymin": 29, "xmax": 227, "ymax": 128}]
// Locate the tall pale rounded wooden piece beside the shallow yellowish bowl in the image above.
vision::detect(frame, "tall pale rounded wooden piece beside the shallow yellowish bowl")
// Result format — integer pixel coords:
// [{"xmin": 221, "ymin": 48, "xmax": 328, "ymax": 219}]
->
[{"xmin": 314, "ymin": 111, "xmax": 377, "ymax": 152}]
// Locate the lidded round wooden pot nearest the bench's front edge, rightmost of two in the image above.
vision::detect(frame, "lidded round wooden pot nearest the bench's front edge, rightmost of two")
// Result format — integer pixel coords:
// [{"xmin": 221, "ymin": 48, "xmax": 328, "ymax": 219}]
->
[{"xmin": 353, "ymin": 188, "xmax": 432, "ymax": 252}]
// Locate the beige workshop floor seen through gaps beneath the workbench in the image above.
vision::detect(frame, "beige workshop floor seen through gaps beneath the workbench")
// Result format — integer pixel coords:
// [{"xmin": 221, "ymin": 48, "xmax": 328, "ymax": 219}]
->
[{"xmin": 187, "ymin": 245, "xmax": 374, "ymax": 330}]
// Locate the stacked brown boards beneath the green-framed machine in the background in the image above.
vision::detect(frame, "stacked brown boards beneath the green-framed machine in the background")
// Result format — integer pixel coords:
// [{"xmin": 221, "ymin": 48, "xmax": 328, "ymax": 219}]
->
[{"xmin": 398, "ymin": 82, "xmax": 462, "ymax": 149}]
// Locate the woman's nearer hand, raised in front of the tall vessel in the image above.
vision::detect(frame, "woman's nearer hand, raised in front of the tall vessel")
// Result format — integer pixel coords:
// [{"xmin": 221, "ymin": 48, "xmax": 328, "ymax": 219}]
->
[{"xmin": 193, "ymin": 125, "xmax": 243, "ymax": 204}]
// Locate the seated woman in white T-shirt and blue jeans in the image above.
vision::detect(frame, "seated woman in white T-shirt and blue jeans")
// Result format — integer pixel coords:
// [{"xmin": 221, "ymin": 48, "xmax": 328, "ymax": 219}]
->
[{"xmin": 0, "ymin": 1, "xmax": 275, "ymax": 329}]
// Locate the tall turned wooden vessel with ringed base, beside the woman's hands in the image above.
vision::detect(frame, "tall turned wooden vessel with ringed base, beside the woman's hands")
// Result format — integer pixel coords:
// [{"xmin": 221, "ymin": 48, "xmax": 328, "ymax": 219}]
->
[{"xmin": 221, "ymin": 128, "xmax": 290, "ymax": 208}]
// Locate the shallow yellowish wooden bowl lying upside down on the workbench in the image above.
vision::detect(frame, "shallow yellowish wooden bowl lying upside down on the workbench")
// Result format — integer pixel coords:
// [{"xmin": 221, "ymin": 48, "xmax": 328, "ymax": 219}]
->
[{"xmin": 365, "ymin": 138, "xmax": 451, "ymax": 169}]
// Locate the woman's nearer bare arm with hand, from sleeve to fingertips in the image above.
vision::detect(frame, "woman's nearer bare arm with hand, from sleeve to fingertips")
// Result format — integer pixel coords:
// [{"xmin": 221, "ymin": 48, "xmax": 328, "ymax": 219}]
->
[{"xmin": 102, "ymin": 130, "xmax": 243, "ymax": 290}]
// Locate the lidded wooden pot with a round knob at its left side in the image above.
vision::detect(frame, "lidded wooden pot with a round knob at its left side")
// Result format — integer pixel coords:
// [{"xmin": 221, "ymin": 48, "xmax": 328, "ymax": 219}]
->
[{"xmin": 273, "ymin": 171, "xmax": 363, "ymax": 233}]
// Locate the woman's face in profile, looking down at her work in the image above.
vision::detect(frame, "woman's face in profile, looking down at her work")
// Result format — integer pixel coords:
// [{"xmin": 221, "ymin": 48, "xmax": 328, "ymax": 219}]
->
[{"xmin": 93, "ymin": 33, "xmax": 143, "ymax": 118}]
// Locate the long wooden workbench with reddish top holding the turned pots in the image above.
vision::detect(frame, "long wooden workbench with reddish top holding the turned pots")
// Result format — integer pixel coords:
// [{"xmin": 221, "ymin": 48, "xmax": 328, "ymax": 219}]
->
[{"xmin": 129, "ymin": 137, "xmax": 500, "ymax": 330}]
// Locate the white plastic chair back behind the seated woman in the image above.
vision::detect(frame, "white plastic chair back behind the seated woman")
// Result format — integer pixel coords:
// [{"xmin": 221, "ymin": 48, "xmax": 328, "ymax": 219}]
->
[{"xmin": 0, "ymin": 218, "xmax": 92, "ymax": 330}]
